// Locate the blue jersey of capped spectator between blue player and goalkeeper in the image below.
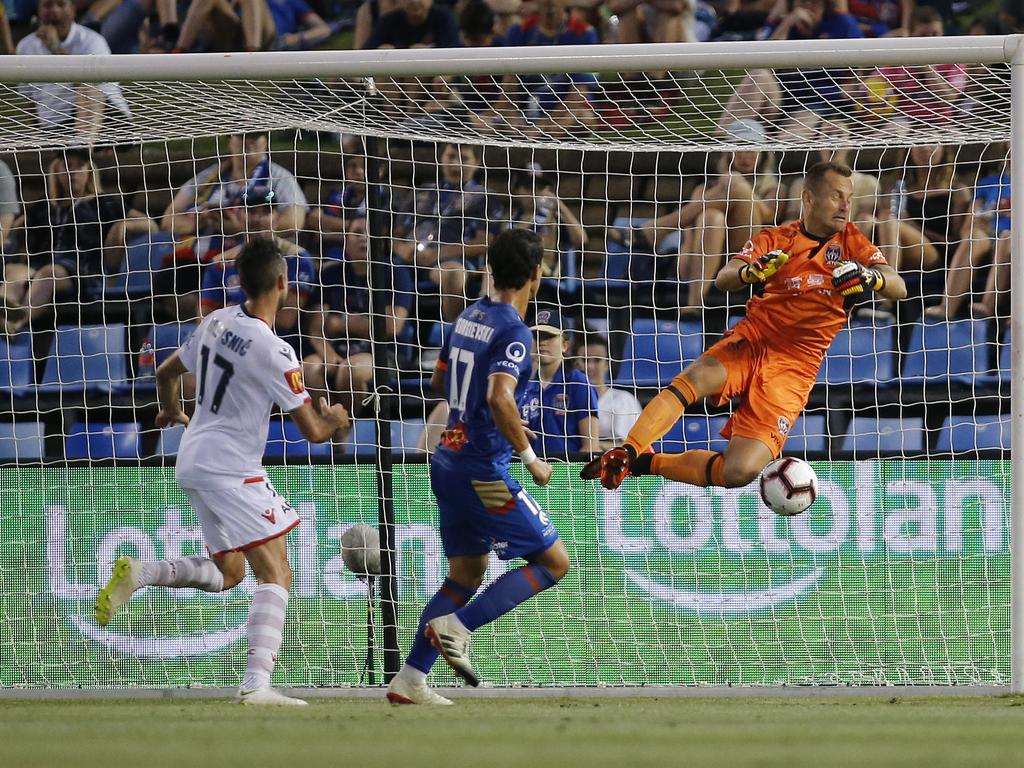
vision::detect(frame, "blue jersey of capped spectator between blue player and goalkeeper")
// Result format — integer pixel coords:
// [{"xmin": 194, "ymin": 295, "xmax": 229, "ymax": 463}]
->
[{"xmin": 520, "ymin": 366, "xmax": 597, "ymax": 459}]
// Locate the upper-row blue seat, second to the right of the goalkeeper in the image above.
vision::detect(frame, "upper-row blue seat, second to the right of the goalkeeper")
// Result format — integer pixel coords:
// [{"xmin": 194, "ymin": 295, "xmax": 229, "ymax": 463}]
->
[{"xmin": 903, "ymin": 319, "xmax": 988, "ymax": 383}]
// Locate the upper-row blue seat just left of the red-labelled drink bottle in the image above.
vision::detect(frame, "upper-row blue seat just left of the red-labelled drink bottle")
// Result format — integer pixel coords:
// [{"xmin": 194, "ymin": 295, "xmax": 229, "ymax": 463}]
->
[{"xmin": 39, "ymin": 325, "xmax": 128, "ymax": 392}]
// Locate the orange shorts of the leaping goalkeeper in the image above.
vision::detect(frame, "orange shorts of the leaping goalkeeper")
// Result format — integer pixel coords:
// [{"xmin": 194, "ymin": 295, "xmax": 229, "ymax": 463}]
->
[{"xmin": 705, "ymin": 322, "xmax": 821, "ymax": 457}]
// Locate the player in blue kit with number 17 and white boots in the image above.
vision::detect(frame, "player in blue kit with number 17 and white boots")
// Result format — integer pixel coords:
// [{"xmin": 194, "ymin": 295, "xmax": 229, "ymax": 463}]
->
[{"xmin": 387, "ymin": 229, "xmax": 569, "ymax": 705}]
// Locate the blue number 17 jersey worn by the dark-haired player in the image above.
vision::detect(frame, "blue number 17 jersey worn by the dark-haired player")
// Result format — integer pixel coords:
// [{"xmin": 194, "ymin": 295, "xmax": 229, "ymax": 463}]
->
[{"xmin": 435, "ymin": 299, "xmax": 532, "ymax": 478}]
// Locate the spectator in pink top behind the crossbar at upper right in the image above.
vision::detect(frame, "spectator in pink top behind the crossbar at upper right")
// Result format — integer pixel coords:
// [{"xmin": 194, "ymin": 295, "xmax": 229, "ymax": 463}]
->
[{"xmin": 865, "ymin": 5, "xmax": 968, "ymax": 129}]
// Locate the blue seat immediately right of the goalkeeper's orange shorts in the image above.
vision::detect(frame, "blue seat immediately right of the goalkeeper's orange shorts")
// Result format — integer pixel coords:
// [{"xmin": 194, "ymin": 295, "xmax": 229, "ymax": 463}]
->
[{"xmin": 818, "ymin": 319, "xmax": 896, "ymax": 384}]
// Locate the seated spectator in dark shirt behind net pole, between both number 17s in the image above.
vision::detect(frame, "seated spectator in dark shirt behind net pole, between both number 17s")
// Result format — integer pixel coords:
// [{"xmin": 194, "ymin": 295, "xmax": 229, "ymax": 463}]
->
[{"xmin": 302, "ymin": 217, "xmax": 416, "ymax": 413}]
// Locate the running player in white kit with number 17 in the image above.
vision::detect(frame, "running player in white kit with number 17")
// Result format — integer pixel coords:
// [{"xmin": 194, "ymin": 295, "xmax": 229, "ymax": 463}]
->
[{"xmin": 96, "ymin": 239, "xmax": 348, "ymax": 706}]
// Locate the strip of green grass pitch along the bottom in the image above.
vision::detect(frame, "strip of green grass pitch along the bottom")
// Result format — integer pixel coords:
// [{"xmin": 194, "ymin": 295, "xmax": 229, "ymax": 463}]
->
[{"xmin": 0, "ymin": 695, "xmax": 1024, "ymax": 768}]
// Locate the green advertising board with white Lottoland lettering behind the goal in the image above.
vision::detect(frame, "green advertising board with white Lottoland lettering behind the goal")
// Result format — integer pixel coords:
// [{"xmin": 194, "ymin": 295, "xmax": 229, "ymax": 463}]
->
[{"xmin": 0, "ymin": 461, "xmax": 1010, "ymax": 687}]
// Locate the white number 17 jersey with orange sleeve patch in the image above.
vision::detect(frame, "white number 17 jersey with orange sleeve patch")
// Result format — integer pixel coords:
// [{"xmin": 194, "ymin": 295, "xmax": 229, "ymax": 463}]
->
[{"xmin": 176, "ymin": 306, "xmax": 310, "ymax": 488}]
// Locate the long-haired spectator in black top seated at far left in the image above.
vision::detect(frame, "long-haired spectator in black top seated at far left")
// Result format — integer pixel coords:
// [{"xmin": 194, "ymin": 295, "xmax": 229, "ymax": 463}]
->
[{"xmin": 14, "ymin": 150, "xmax": 156, "ymax": 330}]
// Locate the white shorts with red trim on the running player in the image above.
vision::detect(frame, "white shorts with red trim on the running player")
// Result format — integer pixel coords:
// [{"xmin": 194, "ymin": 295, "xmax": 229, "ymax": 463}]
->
[{"xmin": 182, "ymin": 477, "xmax": 299, "ymax": 557}]
